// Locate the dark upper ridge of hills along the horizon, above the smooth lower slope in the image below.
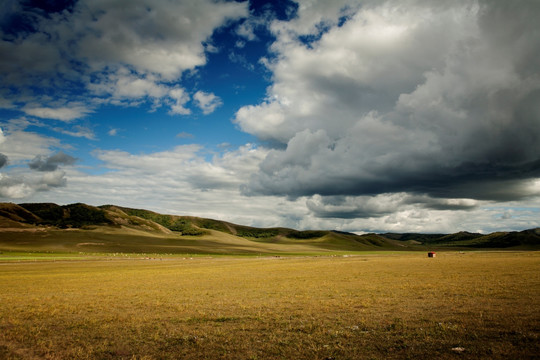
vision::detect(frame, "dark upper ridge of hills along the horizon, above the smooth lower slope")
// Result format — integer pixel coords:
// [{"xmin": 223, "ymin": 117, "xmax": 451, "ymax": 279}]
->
[{"xmin": 0, "ymin": 203, "xmax": 540, "ymax": 251}]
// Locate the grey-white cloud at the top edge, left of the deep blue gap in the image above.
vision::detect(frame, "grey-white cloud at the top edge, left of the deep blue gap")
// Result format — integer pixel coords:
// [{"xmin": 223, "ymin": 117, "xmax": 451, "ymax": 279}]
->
[{"xmin": 73, "ymin": 0, "xmax": 247, "ymax": 80}]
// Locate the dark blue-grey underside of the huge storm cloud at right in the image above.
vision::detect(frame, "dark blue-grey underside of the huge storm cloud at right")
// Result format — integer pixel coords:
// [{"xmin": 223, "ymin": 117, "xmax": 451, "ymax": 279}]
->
[{"xmin": 246, "ymin": 146, "xmax": 540, "ymax": 202}]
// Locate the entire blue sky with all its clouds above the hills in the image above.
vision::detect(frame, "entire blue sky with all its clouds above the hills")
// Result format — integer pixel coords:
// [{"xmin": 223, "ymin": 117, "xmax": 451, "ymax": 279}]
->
[{"xmin": 0, "ymin": 0, "xmax": 540, "ymax": 233}]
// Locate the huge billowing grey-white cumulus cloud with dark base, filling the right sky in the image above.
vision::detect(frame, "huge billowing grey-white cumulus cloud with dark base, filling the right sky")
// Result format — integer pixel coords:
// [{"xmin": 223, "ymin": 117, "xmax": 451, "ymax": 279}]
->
[{"xmin": 235, "ymin": 1, "xmax": 540, "ymax": 210}]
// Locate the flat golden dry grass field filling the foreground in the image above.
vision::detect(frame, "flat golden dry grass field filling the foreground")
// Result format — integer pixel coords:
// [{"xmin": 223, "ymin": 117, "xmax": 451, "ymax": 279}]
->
[{"xmin": 0, "ymin": 252, "xmax": 540, "ymax": 359}]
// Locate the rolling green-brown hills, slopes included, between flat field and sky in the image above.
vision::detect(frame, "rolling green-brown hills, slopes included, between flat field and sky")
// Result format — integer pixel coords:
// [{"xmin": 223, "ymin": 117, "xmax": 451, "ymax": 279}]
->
[{"xmin": 0, "ymin": 203, "xmax": 540, "ymax": 254}]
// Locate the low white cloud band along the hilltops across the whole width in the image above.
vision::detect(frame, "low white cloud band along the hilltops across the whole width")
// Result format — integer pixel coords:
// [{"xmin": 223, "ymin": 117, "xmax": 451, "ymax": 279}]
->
[{"xmin": 4, "ymin": 139, "xmax": 540, "ymax": 232}]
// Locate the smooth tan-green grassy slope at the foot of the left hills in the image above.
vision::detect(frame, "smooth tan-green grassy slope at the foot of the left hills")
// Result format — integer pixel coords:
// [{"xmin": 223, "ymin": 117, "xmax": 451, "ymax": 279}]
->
[{"xmin": 0, "ymin": 227, "xmax": 373, "ymax": 255}]
